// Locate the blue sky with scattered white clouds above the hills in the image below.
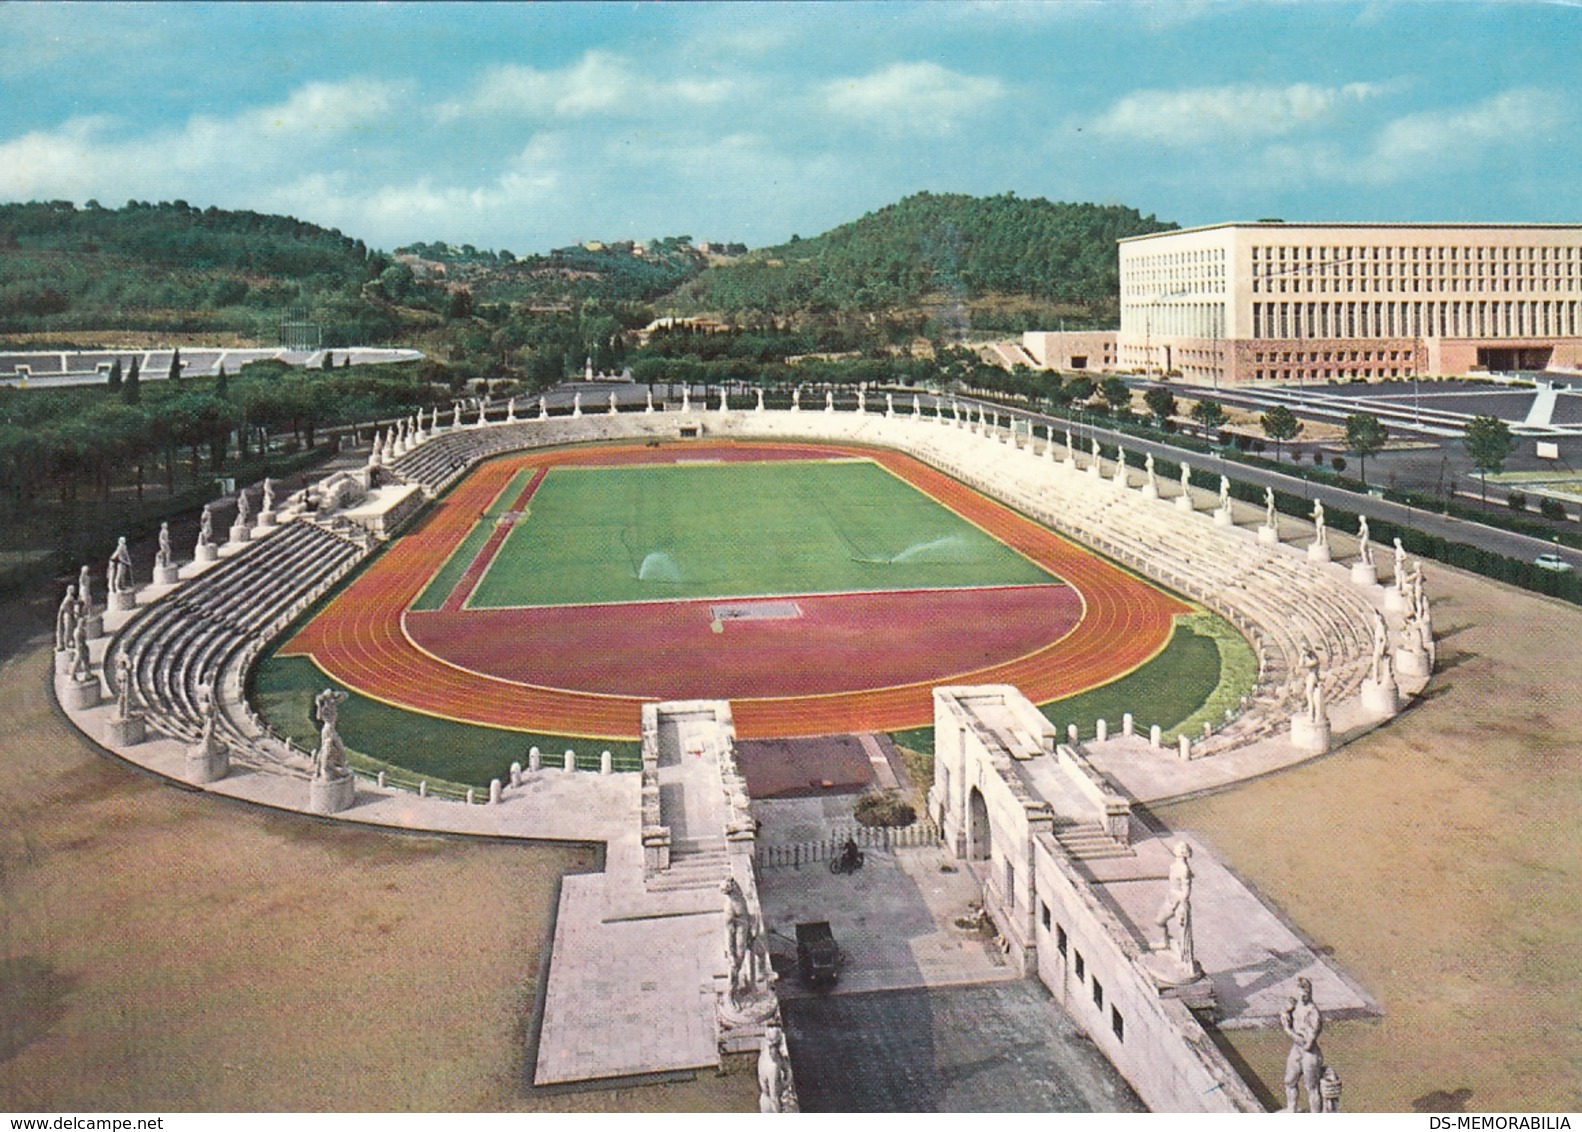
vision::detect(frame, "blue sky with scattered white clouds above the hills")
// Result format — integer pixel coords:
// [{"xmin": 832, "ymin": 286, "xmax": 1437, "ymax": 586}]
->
[{"xmin": 0, "ymin": 0, "xmax": 1582, "ymax": 253}]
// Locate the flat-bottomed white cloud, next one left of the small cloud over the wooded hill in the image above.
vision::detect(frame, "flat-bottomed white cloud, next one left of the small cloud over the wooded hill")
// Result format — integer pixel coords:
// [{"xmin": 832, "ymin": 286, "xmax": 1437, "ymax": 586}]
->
[{"xmin": 435, "ymin": 51, "xmax": 736, "ymax": 122}]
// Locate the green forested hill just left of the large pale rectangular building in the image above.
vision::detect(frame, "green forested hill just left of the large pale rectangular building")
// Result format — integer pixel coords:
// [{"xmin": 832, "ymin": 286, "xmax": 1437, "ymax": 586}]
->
[{"xmin": 676, "ymin": 193, "xmax": 1177, "ymax": 322}]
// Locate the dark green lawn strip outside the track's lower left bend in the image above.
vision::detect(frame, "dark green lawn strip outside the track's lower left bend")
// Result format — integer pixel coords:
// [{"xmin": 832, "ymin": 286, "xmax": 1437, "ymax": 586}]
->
[{"xmin": 253, "ymin": 656, "xmax": 642, "ymax": 794}]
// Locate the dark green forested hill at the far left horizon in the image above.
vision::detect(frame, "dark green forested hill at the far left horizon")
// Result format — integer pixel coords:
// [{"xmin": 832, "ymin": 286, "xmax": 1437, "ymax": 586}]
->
[{"xmin": 0, "ymin": 201, "xmax": 394, "ymax": 341}]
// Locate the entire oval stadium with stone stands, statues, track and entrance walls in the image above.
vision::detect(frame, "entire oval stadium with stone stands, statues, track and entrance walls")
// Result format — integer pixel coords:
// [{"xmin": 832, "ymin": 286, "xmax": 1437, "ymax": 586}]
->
[{"xmin": 55, "ymin": 392, "xmax": 1433, "ymax": 1110}]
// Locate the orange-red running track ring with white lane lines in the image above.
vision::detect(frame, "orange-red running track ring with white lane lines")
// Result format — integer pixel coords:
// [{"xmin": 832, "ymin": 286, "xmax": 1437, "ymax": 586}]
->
[{"xmin": 280, "ymin": 444, "xmax": 1190, "ymax": 738}]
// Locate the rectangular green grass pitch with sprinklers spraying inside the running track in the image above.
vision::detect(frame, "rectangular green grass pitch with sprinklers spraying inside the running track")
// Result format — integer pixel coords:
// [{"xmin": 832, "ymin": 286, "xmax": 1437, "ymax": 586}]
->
[{"xmin": 468, "ymin": 460, "xmax": 1057, "ymax": 609}]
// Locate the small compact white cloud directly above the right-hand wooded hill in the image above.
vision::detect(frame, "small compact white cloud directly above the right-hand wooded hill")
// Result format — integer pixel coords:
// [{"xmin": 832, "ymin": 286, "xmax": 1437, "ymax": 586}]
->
[{"xmin": 823, "ymin": 62, "xmax": 1005, "ymax": 131}]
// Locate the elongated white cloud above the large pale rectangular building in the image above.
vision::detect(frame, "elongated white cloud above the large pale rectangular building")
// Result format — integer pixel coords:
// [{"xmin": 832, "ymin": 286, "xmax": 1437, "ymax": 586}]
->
[{"xmin": 1092, "ymin": 82, "xmax": 1387, "ymax": 145}]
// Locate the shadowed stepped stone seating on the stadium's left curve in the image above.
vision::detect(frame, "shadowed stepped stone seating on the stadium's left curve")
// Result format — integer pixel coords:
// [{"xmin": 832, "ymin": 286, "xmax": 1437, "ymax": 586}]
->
[{"xmin": 106, "ymin": 522, "xmax": 365, "ymax": 772}]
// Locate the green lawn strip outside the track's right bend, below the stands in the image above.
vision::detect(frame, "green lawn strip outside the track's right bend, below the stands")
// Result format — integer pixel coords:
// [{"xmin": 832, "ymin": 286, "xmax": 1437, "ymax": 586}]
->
[{"xmin": 891, "ymin": 612, "xmax": 1258, "ymax": 754}]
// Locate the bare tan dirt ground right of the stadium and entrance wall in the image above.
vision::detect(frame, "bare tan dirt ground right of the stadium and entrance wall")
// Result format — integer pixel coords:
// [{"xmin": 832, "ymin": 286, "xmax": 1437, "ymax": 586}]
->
[{"xmin": 1160, "ymin": 566, "xmax": 1582, "ymax": 1111}]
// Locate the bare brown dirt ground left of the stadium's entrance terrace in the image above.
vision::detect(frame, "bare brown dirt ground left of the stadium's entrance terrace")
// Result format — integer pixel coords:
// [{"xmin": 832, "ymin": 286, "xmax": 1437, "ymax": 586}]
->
[{"xmin": 0, "ymin": 607, "xmax": 758, "ymax": 1111}]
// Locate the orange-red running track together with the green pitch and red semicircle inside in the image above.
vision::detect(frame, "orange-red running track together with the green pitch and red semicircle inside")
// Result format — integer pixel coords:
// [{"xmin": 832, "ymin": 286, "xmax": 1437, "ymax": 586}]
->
[{"xmin": 278, "ymin": 441, "xmax": 1190, "ymax": 740}]
